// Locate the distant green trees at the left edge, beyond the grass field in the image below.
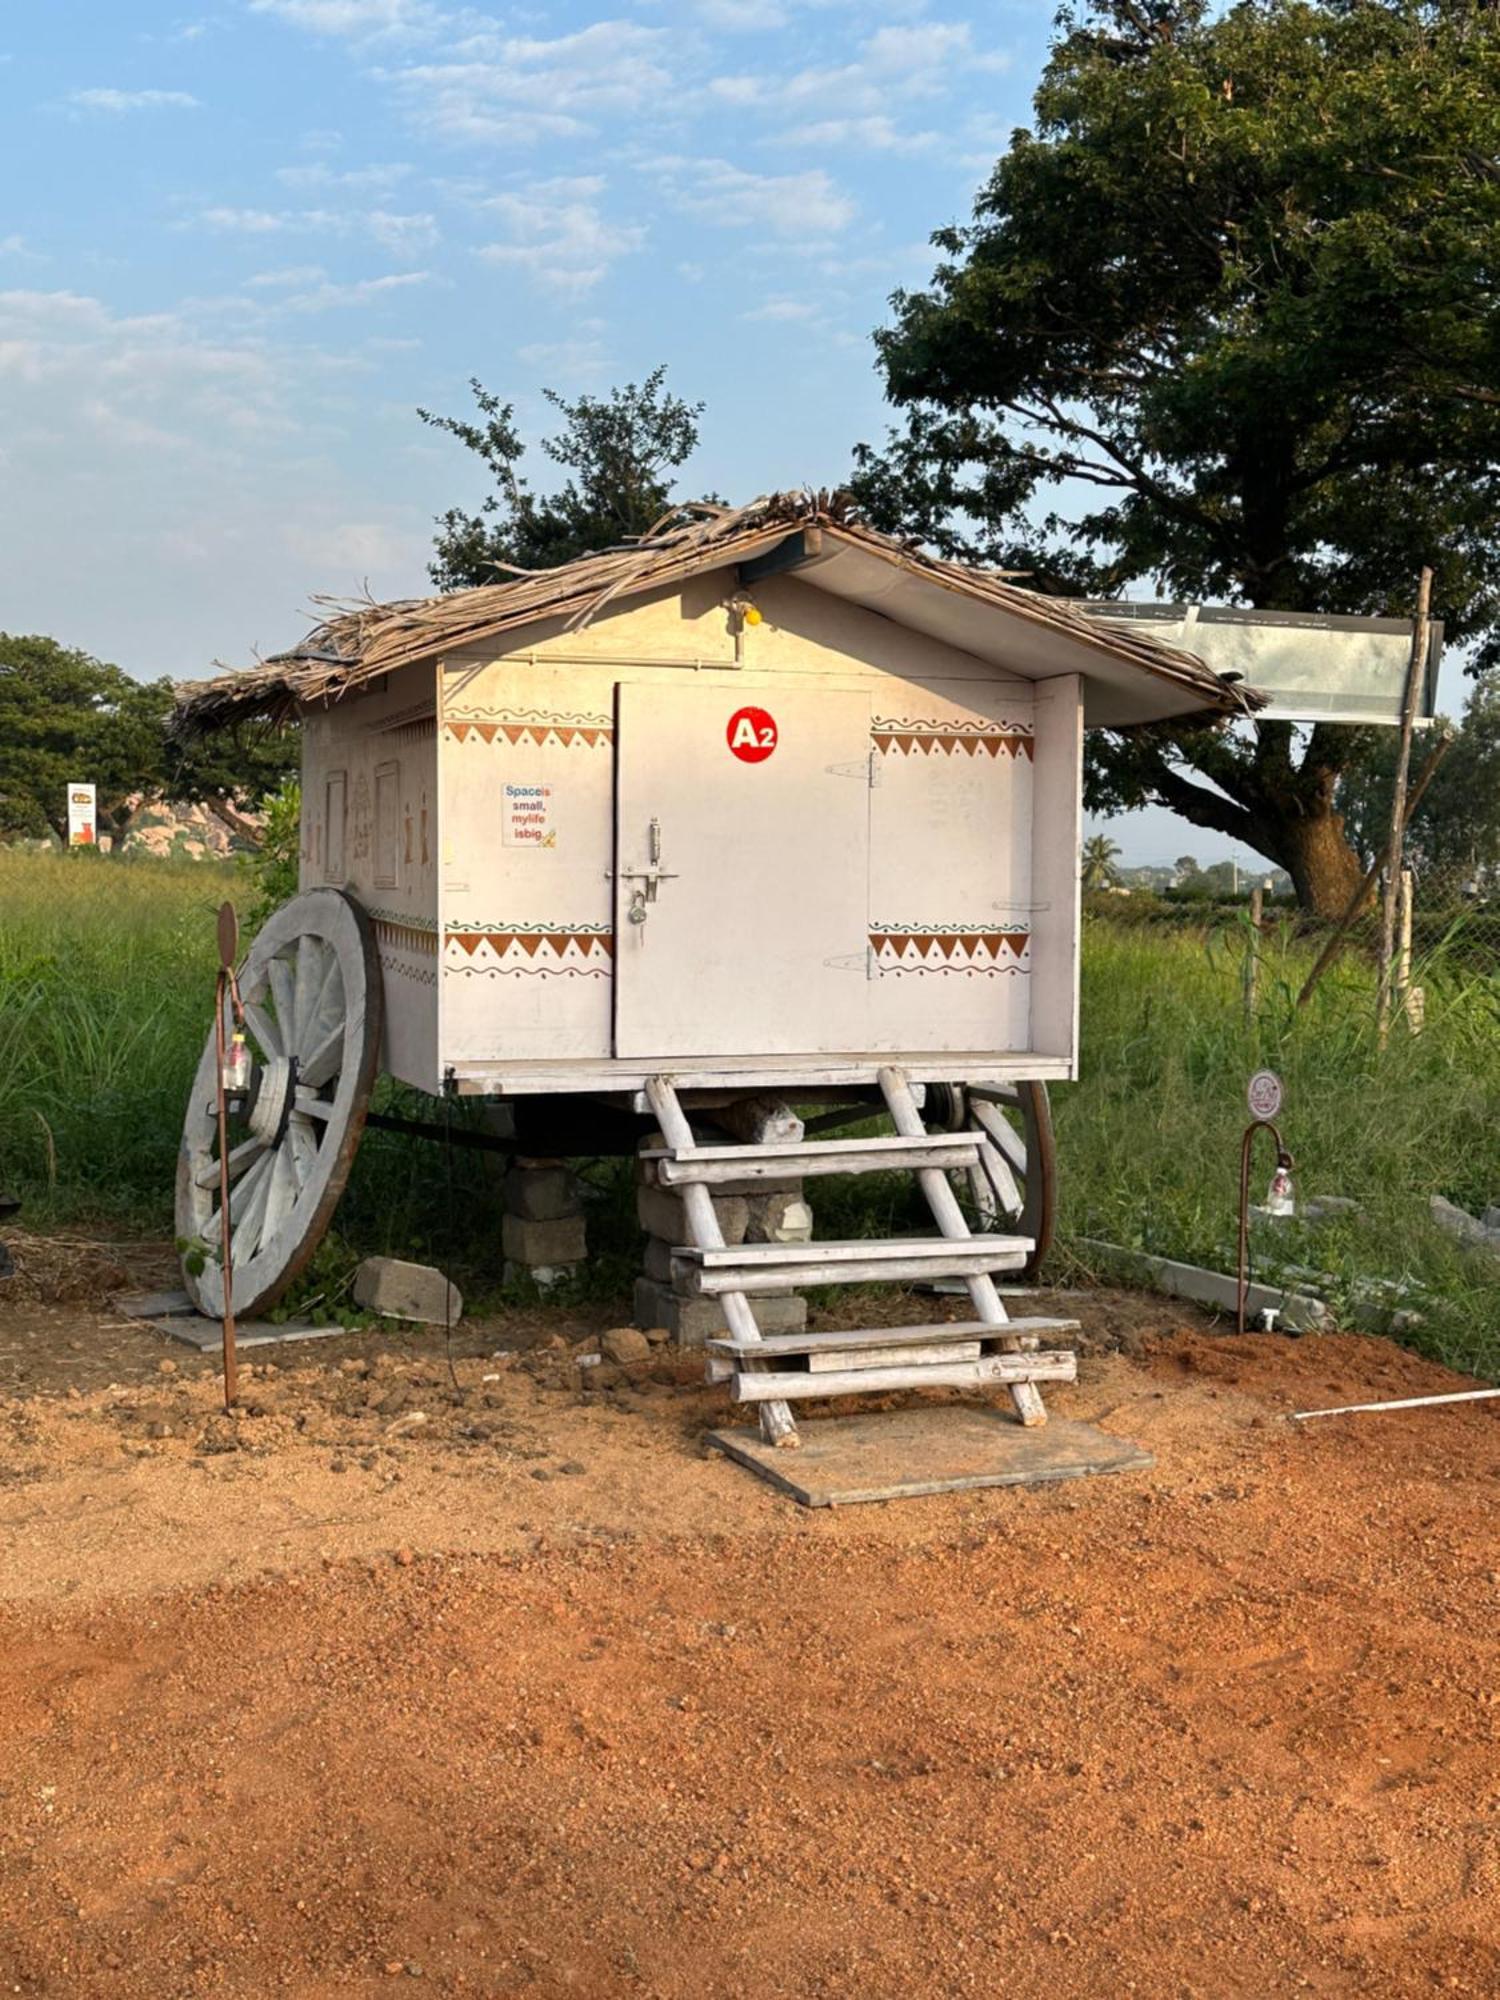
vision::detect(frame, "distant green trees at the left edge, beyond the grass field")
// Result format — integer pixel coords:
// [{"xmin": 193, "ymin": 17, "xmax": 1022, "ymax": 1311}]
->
[{"xmin": 0, "ymin": 632, "xmax": 296, "ymax": 850}]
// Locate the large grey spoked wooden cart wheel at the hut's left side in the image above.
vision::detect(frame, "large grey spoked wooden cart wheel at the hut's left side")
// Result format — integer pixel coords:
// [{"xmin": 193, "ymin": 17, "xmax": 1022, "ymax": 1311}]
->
[{"xmin": 176, "ymin": 888, "xmax": 380, "ymax": 1318}]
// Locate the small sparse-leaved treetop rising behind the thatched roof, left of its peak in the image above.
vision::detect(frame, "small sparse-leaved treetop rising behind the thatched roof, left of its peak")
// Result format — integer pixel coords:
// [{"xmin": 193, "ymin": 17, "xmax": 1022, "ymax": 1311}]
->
[{"xmin": 416, "ymin": 368, "xmax": 704, "ymax": 590}]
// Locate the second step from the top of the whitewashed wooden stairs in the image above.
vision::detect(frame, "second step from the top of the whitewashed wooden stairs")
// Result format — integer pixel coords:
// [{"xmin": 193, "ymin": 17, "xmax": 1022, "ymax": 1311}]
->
[{"xmin": 672, "ymin": 1236, "xmax": 1032, "ymax": 1298}]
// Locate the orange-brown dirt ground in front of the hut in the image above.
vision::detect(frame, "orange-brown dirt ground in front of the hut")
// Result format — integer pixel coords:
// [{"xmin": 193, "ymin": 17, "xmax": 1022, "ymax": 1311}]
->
[{"xmin": 0, "ymin": 1256, "xmax": 1500, "ymax": 2000}]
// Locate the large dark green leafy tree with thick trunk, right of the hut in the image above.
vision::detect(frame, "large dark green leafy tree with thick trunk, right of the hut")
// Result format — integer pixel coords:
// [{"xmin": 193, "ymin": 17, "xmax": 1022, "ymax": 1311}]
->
[{"xmin": 858, "ymin": 0, "xmax": 1500, "ymax": 912}]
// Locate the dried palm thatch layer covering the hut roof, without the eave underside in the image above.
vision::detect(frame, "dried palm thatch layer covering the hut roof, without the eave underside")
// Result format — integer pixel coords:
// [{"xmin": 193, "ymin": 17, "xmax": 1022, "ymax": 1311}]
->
[{"xmin": 178, "ymin": 492, "xmax": 1254, "ymax": 734}]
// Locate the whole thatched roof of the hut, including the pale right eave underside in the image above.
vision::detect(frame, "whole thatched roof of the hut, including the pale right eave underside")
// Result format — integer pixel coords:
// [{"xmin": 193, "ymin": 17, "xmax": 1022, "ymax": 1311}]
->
[{"xmin": 178, "ymin": 492, "xmax": 1258, "ymax": 734}]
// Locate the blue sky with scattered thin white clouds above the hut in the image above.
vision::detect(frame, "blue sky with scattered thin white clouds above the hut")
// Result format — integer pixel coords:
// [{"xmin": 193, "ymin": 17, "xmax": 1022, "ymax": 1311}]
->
[{"xmin": 0, "ymin": 0, "xmax": 1432, "ymax": 860}]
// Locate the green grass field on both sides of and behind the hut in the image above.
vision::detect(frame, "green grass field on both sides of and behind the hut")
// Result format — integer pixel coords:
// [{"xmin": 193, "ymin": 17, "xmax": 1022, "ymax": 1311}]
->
[{"xmin": 0, "ymin": 850, "xmax": 1500, "ymax": 1374}]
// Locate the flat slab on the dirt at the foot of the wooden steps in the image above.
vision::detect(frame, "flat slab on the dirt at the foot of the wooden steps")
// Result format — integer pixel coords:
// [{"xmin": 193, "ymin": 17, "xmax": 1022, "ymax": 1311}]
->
[{"xmin": 708, "ymin": 1402, "xmax": 1154, "ymax": 1506}]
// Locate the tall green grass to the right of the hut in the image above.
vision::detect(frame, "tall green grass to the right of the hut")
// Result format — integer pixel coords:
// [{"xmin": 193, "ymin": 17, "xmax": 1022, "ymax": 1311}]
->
[{"xmin": 1054, "ymin": 918, "xmax": 1500, "ymax": 1372}]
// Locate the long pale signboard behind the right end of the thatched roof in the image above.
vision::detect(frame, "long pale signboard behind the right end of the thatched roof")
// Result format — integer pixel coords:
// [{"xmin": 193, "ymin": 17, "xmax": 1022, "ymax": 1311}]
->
[{"xmin": 1080, "ymin": 602, "xmax": 1442, "ymax": 724}]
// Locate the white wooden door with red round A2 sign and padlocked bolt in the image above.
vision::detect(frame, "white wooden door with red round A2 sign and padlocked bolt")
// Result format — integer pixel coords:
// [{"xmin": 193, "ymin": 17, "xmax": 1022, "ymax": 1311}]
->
[{"xmin": 614, "ymin": 676, "xmax": 870, "ymax": 1058}]
